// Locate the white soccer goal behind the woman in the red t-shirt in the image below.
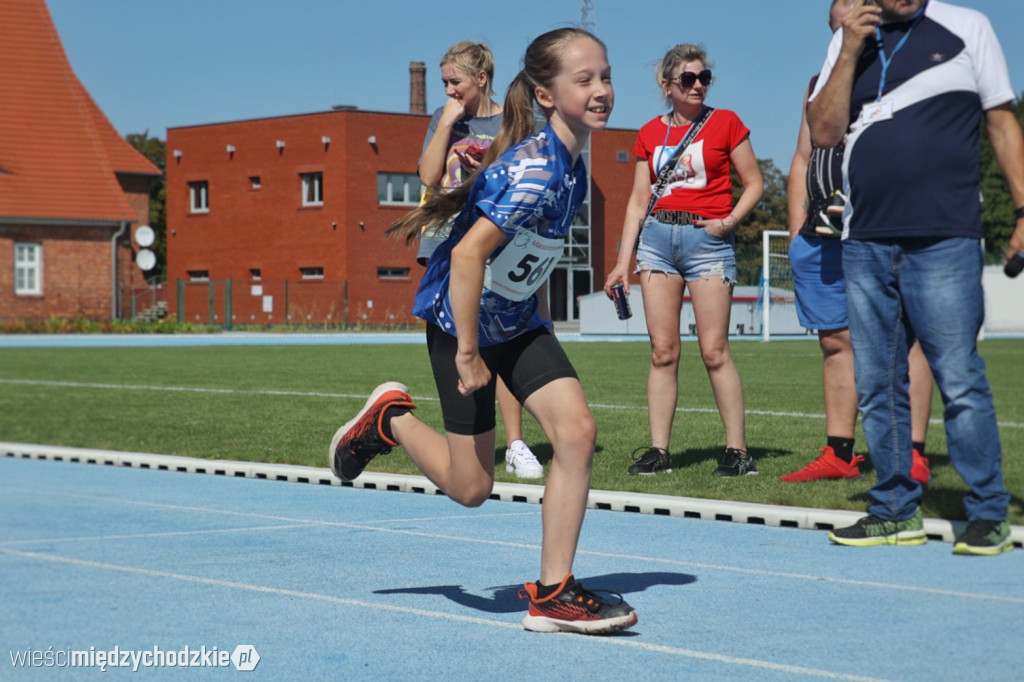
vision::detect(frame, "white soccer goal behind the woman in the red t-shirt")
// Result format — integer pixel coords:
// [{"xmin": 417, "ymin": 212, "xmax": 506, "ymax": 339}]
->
[{"xmin": 758, "ymin": 229, "xmax": 806, "ymax": 341}]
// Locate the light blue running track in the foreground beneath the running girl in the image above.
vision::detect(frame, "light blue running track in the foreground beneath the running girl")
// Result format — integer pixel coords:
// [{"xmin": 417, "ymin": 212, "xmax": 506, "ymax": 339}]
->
[{"xmin": 0, "ymin": 452, "xmax": 1024, "ymax": 681}]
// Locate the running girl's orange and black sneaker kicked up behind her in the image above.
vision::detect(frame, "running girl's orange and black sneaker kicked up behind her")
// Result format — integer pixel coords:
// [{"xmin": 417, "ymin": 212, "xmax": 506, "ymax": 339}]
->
[{"xmin": 328, "ymin": 381, "xmax": 416, "ymax": 481}]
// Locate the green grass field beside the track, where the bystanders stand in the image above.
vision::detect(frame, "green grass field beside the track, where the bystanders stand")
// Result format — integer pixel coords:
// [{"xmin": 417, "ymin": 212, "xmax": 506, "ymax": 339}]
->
[{"xmin": 0, "ymin": 339, "xmax": 1024, "ymax": 524}]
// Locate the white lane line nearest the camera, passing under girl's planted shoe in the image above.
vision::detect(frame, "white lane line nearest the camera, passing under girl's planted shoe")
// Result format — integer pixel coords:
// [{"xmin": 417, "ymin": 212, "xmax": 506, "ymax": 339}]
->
[{"xmin": 0, "ymin": 548, "xmax": 886, "ymax": 682}]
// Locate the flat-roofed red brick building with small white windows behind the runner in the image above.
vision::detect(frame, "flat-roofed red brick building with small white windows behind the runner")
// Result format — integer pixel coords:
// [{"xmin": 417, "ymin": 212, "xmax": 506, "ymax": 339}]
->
[{"xmin": 167, "ymin": 104, "xmax": 636, "ymax": 326}]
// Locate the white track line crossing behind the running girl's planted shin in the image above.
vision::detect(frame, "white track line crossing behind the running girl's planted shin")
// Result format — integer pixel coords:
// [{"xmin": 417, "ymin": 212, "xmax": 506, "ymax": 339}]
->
[{"xmin": 0, "ymin": 491, "xmax": 1024, "ymax": 604}]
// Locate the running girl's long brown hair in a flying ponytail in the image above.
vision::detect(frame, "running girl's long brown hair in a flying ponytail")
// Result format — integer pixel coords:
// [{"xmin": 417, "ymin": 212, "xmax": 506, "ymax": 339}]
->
[{"xmin": 384, "ymin": 28, "xmax": 606, "ymax": 243}]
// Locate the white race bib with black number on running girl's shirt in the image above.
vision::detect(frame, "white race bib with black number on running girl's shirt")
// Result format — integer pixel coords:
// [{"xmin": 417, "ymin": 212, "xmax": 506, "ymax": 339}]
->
[{"xmin": 483, "ymin": 227, "xmax": 565, "ymax": 301}]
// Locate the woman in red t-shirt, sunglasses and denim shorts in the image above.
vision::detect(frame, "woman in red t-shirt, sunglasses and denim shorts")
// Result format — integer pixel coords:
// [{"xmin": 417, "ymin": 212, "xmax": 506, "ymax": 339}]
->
[{"xmin": 604, "ymin": 44, "xmax": 764, "ymax": 476}]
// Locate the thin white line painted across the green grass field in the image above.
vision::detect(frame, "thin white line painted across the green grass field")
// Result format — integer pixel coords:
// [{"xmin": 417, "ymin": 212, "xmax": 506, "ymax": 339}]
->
[{"xmin": 0, "ymin": 378, "xmax": 1024, "ymax": 429}]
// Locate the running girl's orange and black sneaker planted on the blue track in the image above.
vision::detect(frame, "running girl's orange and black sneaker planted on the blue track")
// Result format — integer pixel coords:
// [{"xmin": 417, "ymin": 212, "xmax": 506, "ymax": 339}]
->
[{"xmin": 519, "ymin": 573, "xmax": 637, "ymax": 635}]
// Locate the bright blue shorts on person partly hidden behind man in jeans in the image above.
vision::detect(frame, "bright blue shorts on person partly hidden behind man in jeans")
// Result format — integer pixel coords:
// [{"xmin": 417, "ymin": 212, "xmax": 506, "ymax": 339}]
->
[{"xmin": 790, "ymin": 235, "xmax": 850, "ymax": 332}]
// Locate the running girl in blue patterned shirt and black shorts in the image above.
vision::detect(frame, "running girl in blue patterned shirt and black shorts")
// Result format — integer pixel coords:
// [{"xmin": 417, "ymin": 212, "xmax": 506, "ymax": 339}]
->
[{"xmin": 330, "ymin": 29, "xmax": 637, "ymax": 634}]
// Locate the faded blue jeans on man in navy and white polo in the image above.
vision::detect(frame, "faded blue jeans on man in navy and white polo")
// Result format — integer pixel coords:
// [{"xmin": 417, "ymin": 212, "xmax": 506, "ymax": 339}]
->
[{"xmin": 843, "ymin": 239, "xmax": 1010, "ymax": 521}]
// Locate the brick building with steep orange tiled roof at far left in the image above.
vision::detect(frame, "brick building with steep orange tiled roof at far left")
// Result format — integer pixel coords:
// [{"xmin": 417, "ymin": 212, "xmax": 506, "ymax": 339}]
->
[{"xmin": 0, "ymin": 0, "xmax": 161, "ymax": 319}]
